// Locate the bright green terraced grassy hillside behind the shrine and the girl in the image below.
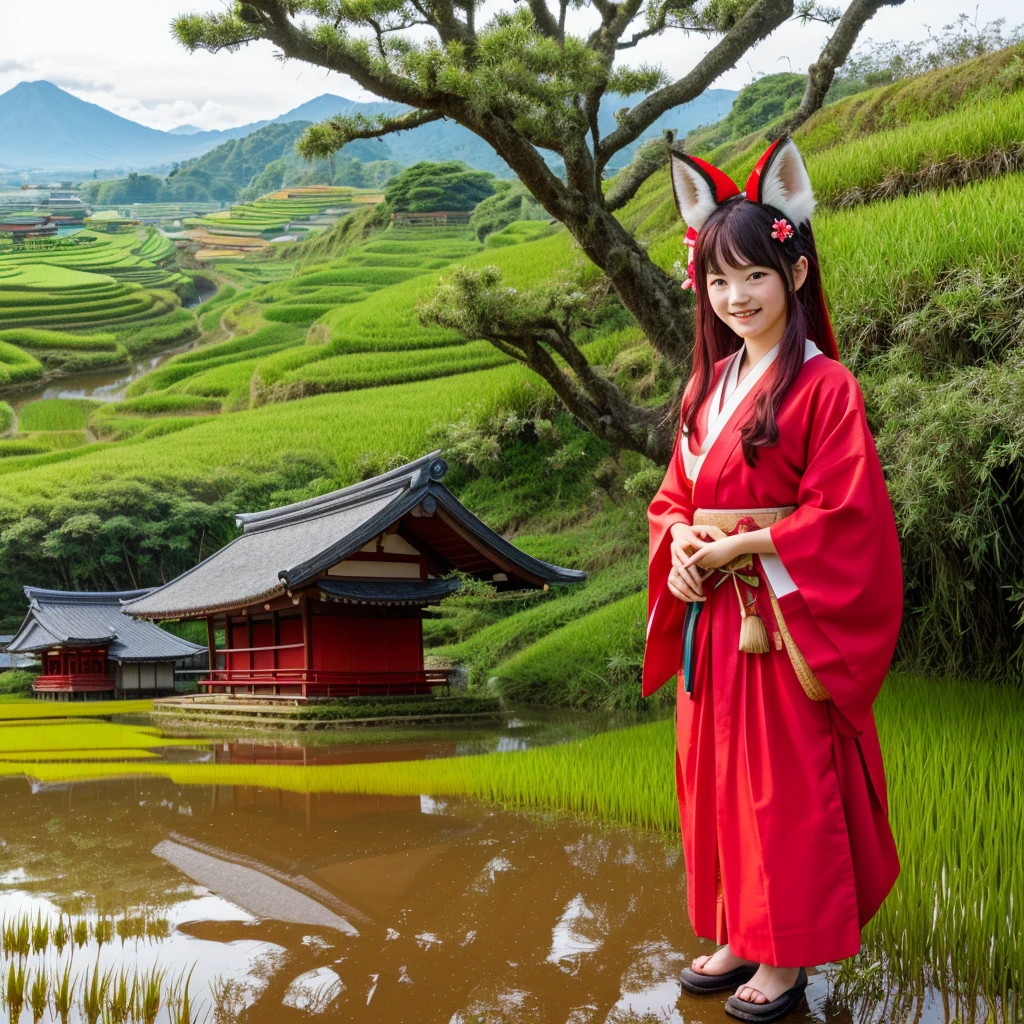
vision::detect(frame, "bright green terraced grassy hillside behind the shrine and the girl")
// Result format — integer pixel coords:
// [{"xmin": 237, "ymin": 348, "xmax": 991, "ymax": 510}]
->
[{"xmin": 0, "ymin": 50, "xmax": 1024, "ymax": 688}]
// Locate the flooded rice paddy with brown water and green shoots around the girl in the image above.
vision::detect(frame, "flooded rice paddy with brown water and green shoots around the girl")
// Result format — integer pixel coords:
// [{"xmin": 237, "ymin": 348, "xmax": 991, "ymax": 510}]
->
[{"xmin": 0, "ymin": 678, "xmax": 1024, "ymax": 1024}]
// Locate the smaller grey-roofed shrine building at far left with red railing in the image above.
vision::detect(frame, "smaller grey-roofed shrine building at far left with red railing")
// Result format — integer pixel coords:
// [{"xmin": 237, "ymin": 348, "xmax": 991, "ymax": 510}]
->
[{"xmin": 5, "ymin": 587, "xmax": 206, "ymax": 699}]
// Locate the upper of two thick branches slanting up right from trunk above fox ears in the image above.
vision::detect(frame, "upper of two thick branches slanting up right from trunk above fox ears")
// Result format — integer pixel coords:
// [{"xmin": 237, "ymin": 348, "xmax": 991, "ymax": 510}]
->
[{"xmin": 595, "ymin": 0, "xmax": 793, "ymax": 170}]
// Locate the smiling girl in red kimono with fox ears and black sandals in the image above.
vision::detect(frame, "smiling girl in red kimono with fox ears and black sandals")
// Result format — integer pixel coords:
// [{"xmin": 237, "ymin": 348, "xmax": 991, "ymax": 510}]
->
[{"xmin": 643, "ymin": 138, "xmax": 903, "ymax": 1021}]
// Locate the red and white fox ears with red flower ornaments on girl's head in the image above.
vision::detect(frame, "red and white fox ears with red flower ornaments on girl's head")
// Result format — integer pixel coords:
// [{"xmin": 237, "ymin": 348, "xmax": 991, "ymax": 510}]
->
[{"xmin": 670, "ymin": 135, "xmax": 814, "ymax": 288}]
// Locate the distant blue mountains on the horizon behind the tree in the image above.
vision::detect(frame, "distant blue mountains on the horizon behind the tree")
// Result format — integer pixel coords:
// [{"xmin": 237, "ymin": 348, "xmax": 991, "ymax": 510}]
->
[{"xmin": 0, "ymin": 81, "xmax": 736, "ymax": 176}]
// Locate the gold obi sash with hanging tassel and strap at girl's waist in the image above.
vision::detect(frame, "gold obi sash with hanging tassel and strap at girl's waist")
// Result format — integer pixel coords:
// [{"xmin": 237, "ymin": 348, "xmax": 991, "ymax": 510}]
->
[{"xmin": 693, "ymin": 505, "xmax": 828, "ymax": 700}]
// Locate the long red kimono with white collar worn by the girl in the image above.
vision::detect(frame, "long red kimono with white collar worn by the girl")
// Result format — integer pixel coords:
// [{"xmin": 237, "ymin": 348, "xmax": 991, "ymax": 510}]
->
[{"xmin": 643, "ymin": 341, "xmax": 903, "ymax": 967}]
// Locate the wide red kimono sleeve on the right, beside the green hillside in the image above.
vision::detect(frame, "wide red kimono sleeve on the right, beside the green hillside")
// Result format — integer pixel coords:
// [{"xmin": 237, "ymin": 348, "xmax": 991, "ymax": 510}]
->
[{"xmin": 771, "ymin": 362, "xmax": 903, "ymax": 736}]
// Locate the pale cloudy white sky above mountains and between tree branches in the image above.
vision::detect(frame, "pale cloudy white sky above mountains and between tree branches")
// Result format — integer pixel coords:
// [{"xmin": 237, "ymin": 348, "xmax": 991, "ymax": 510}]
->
[{"xmin": 0, "ymin": 0, "xmax": 1024, "ymax": 129}]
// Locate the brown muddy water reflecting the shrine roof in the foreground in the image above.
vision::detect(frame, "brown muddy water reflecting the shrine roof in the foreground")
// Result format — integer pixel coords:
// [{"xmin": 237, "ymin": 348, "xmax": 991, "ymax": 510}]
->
[{"xmin": 0, "ymin": 779, "xmax": 839, "ymax": 1024}]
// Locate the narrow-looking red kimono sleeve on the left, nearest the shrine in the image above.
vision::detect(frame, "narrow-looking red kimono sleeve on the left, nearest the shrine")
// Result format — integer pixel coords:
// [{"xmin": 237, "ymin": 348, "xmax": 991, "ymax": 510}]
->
[{"xmin": 642, "ymin": 421, "xmax": 693, "ymax": 697}]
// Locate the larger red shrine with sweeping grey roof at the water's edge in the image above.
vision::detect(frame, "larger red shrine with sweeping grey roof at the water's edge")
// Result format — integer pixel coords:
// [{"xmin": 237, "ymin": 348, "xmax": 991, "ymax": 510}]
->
[{"xmin": 124, "ymin": 452, "xmax": 587, "ymax": 697}]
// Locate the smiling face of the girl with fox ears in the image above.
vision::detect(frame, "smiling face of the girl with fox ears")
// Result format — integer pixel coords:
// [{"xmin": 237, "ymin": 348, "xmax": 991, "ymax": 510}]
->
[{"xmin": 708, "ymin": 256, "xmax": 807, "ymax": 344}]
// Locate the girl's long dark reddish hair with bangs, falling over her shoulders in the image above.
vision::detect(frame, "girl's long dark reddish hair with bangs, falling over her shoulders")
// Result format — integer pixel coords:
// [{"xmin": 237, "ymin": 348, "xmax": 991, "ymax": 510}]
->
[{"xmin": 680, "ymin": 196, "xmax": 839, "ymax": 466}]
